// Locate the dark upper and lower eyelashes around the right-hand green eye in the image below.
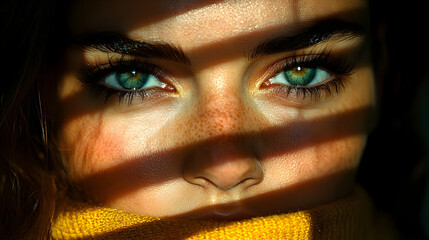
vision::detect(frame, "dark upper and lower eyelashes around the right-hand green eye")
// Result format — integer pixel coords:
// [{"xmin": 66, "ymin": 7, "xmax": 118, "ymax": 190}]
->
[{"xmin": 268, "ymin": 51, "xmax": 353, "ymax": 100}]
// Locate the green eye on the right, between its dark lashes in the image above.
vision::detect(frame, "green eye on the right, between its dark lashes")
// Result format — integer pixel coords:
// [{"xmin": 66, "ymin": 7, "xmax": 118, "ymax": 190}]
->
[{"xmin": 269, "ymin": 66, "xmax": 331, "ymax": 87}]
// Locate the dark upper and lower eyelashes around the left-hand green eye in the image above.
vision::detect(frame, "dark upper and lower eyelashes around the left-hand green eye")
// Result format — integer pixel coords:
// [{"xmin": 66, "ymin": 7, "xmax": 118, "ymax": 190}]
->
[{"xmin": 79, "ymin": 56, "xmax": 167, "ymax": 104}]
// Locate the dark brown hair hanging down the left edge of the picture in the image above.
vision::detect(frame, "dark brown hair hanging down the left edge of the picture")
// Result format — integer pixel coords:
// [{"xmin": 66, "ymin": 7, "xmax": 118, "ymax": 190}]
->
[{"xmin": 0, "ymin": 0, "xmax": 67, "ymax": 239}]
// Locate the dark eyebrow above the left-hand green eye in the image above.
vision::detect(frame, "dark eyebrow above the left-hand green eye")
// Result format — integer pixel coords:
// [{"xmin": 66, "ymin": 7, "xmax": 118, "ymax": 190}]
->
[{"xmin": 70, "ymin": 32, "xmax": 190, "ymax": 65}]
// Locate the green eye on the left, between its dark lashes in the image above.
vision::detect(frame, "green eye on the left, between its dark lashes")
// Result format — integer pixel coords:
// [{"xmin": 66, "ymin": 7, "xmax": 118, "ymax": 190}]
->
[{"xmin": 103, "ymin": 70, "xmax": 166, "ymax": 91}]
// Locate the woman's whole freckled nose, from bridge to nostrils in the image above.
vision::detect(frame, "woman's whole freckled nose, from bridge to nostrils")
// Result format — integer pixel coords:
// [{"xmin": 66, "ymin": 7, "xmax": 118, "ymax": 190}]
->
[{"xmin": 183, "ymin": 68, "xmax": 264, "ymax": 191}]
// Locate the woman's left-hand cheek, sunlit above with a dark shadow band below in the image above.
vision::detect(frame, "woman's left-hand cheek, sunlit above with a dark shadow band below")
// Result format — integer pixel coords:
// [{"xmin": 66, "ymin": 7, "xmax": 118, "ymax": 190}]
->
[{"xmin": 55, "ymin": 105, "xmax": 179, "ymax": 202}]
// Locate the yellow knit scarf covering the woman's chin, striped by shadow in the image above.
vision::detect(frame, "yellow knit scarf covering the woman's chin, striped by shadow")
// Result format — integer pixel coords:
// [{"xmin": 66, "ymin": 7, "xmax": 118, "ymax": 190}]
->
[{"xmin": 51, "ymin": 188, "xmax": 384, "ymax": 240}]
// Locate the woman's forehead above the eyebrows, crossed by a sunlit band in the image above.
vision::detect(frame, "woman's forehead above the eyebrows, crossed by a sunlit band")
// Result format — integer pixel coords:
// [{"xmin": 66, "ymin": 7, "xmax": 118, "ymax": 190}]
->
[{"xmin": 69, "ymin": 0, "xmax": 367, "ymax": 49}]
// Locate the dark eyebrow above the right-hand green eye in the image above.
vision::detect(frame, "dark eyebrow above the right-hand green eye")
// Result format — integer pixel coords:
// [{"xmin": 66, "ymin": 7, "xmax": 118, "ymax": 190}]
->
[{"xmin": 249, "ymin": 19, "xmax": 364, "ymax": 60}]
